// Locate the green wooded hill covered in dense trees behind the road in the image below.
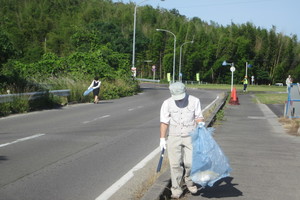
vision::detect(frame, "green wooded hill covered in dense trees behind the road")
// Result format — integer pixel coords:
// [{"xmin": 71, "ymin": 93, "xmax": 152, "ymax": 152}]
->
[{"xmin": 0, "ymin": 0, "xmax": 300, "ymax": 87}]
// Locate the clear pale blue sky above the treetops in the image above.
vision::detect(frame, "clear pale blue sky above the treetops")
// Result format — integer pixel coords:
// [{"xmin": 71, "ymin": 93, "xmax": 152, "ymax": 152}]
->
[{"xmin": 113, "ymin": 0, "xmax": 300, "ymax": 38}]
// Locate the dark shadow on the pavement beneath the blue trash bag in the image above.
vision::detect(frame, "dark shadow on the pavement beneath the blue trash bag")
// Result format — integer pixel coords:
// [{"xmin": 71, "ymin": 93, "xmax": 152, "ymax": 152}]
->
[{"xmin": 192, "ymin": 177, "xmax": 243, "ymax": 198}]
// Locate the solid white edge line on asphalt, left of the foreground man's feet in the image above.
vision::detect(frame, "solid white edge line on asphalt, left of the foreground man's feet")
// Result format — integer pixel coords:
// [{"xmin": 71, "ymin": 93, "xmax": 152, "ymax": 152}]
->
[{"xmin": 95, "ymin": 147, "xmax": 160, "ymax": 200}]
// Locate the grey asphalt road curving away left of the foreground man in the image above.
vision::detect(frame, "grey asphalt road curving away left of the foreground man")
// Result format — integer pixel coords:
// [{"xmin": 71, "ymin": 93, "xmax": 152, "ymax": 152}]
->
[{"xmin": 0, "ymin": 84, "xmax": 223, "ymax": 200}]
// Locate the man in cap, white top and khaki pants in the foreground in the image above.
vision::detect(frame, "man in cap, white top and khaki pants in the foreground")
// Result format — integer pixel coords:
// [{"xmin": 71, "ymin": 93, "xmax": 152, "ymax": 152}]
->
[{"xmin": 160, "ymin": 82, "xmax": 205, "ymax": 198}]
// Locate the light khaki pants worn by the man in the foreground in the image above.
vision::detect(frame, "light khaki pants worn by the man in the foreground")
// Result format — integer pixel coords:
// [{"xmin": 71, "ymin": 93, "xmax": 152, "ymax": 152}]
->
[{"xmin": 167, "ymin": 135, "xmax": 193, "ymax": 194}]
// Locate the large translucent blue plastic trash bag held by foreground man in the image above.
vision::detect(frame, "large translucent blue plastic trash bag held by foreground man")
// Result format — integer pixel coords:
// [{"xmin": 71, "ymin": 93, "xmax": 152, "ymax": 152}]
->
[{"xmin": 191, "ymin": 127, "xmax": 231, "ymax": 187}]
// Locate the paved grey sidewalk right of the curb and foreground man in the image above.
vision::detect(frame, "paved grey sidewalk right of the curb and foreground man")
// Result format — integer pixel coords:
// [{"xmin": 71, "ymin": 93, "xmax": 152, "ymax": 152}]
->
[{"xmin": 181, "ymin": 94, "xmax": 300, "ymax": 200}]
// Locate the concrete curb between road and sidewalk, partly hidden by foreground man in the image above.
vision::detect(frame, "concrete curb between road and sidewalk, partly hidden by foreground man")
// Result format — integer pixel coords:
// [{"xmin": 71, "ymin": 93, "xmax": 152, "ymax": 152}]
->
[{"xmin": 141, "ymin": 92, "xmax": 228, "ymax": 200}]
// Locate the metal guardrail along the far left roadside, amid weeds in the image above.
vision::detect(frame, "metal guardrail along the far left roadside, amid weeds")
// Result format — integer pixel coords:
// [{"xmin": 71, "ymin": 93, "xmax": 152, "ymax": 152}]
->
[{"xmin": 0, "ymin": 90, "xmax": 71, "ymax": 103}]
